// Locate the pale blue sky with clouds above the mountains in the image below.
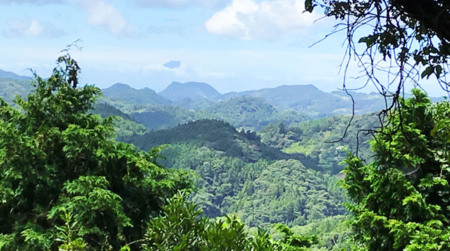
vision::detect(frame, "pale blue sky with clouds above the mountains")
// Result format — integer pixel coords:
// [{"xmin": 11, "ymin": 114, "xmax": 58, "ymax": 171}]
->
[{"xmin": 0, "ymin": 0, "xmax": 442, "ymax": 96}]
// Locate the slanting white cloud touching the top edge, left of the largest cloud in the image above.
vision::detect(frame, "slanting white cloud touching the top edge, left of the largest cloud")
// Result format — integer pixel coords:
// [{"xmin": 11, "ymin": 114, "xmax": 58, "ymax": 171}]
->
[{"xmin": 80, "ymin": 0, "xmax": 134, "ymax": 36}]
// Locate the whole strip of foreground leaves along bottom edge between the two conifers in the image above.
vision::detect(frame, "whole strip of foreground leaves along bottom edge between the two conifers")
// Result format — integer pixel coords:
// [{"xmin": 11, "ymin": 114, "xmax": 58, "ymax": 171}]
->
[{"xmin": 142, "ymin": 193, "xmax": 318, "ymax": 251}]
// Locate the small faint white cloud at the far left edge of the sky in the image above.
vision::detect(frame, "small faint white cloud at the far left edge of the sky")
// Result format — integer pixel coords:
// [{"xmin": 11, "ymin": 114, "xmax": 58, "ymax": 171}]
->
[{"xmin": 3, "ymin": 19, "xmax": 64, "ymax": 38}]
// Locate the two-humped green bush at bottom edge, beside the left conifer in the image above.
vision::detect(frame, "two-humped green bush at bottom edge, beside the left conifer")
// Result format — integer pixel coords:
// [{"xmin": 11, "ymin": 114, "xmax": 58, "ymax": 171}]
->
[{"xmin": 145, "ymin": 193, "xmax": 249, "ymax": 251}]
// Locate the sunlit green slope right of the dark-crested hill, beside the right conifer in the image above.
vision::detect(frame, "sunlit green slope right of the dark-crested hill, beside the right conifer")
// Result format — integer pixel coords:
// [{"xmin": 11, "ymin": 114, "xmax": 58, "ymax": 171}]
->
[{"xmin": 258, "ymin": 113, "xmax": 379, "ymax": 174}]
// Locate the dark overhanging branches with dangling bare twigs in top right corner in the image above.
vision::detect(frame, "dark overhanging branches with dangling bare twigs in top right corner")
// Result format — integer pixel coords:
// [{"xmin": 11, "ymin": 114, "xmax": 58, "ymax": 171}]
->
[{"xmin": 305, "ymin": 0, "xmax": 450, "ymax": 109}]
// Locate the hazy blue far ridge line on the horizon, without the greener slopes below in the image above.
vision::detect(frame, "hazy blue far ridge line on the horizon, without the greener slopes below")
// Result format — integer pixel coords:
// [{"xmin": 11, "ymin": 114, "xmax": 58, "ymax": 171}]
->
[{"xmin": 103, "ymin": 82, "xmax": 384, "ymax": 118}]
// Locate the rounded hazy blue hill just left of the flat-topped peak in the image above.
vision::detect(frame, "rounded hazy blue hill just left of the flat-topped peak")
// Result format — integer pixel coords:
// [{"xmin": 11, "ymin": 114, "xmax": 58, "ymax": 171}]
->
[{"xmin": 102, "ymin": 83, "xmax": 171, "ymax": 105}]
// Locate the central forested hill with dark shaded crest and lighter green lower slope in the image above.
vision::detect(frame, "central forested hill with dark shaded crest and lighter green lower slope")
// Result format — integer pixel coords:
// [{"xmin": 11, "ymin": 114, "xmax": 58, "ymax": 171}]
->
[{"xmin": 121, "ymin": 120, "xmax": 345, "ymax": 227}]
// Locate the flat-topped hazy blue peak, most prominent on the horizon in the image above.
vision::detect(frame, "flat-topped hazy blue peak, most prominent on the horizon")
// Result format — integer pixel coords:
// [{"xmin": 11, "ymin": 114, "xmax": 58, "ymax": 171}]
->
[{"xmin": 158, "ymin": 82, "xmax": 222, "ymax": 102}]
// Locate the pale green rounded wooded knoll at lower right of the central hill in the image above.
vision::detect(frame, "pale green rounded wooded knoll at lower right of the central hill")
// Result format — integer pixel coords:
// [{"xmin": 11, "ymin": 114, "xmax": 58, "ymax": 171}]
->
[{"xmin": 227, "ymin": 159, "xmax": 346, "ymax": 227}]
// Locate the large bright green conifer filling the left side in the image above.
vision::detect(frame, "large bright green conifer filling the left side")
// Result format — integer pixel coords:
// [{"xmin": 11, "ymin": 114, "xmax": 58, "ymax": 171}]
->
[{"xmin": 0, "ymin": 54, "xmax": 190, "ymax": 250}]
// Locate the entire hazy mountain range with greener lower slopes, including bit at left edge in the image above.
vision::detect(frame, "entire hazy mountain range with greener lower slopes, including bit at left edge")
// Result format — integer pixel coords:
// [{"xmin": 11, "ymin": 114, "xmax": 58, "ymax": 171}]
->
[{"xmin": 0, "ymin": 70, "xmax": 408, "ymax": 130}]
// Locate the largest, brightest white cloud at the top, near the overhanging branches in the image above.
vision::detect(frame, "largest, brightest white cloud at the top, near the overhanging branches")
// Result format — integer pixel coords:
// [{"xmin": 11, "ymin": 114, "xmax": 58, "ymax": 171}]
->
[{"xmin": 205, "ymin": 0, "xmax": 317, "ymax": 40}]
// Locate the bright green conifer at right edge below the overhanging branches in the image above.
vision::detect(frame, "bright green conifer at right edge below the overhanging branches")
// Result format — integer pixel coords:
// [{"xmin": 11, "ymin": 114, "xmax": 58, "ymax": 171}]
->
[{"xmin": 342, "ymin": 89, "xmax": 450, "ymax": 250}]
